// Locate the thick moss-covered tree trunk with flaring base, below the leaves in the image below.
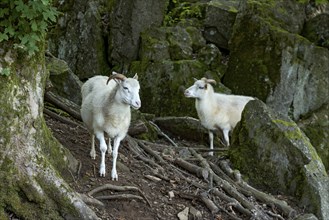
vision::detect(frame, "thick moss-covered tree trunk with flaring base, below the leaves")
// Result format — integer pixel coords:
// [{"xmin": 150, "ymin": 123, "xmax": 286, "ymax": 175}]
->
[{"xmin": 0, "ymin": 44, "xmax": 98, "ymax": 219}]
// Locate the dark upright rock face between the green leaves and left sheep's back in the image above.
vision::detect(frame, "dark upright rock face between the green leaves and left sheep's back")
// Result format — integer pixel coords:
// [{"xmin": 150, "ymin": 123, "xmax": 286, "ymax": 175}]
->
[{"xmin": 48, "ymin": 0, "xmax": 109, "ymax": 79}]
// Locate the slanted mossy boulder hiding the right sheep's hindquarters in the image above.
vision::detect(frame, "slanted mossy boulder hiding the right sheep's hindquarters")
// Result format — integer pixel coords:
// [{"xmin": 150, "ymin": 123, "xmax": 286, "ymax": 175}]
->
[{"xmin": 230, "ymin": 100, "xmax": 329, "ymax": 220}]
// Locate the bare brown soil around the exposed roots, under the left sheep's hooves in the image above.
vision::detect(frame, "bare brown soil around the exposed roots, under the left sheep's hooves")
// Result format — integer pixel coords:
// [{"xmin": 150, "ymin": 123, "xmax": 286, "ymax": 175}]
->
[{"xmin": 45, "ymin": 115, "xmax": 302, "ymax": 220}]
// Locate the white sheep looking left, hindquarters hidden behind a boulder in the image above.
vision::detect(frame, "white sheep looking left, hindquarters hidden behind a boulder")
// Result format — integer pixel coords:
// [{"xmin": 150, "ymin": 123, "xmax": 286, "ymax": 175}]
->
[{"xmin": 184, "ymin": 78, "xmax": 254, "ymax": 155}]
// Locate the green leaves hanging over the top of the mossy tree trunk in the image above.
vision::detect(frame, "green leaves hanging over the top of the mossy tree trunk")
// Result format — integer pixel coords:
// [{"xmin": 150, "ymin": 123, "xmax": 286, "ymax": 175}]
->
[{"xmin": 0, "ymin": 0, "xmax": 59, "ymax": 56}]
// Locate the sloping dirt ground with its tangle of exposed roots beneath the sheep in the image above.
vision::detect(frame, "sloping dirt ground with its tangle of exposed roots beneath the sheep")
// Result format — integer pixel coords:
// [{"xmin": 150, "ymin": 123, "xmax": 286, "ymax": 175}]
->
[{"xmin": 45, "ymin": 111, "xmax": 300, "ymax": 220}]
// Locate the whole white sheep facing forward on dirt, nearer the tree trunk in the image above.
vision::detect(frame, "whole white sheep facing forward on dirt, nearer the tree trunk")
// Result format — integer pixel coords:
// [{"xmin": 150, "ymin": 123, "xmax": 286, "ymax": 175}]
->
[{"xmin": 81, "ymin": 72, "xmax": 141, "ymax": 180}]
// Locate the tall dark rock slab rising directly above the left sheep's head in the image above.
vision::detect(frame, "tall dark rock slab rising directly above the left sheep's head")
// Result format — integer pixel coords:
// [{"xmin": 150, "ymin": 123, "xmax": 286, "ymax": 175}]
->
[{"xmin": 108, "ymin": 0, "xmax": 168, "ymax": 71}]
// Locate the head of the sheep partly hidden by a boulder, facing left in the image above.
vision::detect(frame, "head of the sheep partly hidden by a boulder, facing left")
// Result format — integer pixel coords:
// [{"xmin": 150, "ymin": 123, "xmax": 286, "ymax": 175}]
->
[{"xmin": 184, "ymin": 77, "xmax": 216, "ymax": 99}]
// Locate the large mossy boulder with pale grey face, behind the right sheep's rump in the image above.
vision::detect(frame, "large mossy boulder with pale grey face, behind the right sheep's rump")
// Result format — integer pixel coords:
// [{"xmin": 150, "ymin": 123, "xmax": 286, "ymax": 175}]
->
[{"xmin": 223, "ymin": 0, "xmax": 329, "ymax": 120}]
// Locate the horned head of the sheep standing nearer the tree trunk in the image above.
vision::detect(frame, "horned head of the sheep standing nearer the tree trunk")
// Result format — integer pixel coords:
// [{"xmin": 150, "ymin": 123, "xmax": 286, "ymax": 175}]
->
[{"xmin": 106, "ymin": 72, "xmax": 141, "ymax": 109}]
